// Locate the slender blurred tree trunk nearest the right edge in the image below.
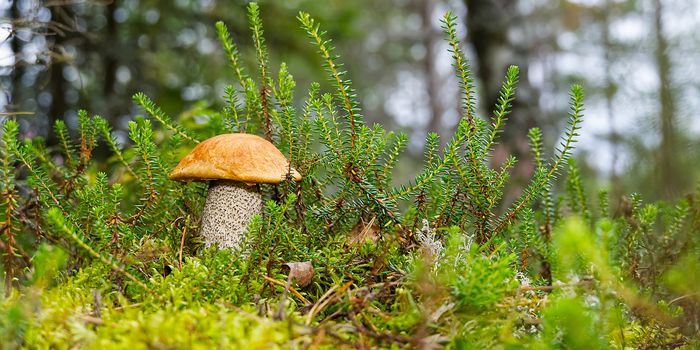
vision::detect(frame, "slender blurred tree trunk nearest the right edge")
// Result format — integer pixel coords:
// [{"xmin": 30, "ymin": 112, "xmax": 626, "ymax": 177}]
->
[{"xmin": 654, "ymin": 0, "xmax": 683, "ymax": 199}]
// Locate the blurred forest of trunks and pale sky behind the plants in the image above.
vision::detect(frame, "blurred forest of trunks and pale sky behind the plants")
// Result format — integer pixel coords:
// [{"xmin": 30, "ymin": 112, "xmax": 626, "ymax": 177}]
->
[{"xmin": 0, "ymin": 0, "xmax": 700, "ymax": 199}]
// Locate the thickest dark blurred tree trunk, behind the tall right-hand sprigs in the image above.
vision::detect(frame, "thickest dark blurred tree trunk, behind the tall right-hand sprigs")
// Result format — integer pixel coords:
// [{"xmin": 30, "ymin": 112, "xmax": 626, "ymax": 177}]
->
[{"xmin": 465, "ymin": 0, "xmax": 539, "ymax": 200}]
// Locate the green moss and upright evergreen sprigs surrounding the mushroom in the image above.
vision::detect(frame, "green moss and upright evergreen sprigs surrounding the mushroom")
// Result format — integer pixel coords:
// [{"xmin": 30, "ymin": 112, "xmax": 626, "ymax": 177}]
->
[{"xmin": 0, "ymin": 3, "xmax": 700, "ymax": 349}]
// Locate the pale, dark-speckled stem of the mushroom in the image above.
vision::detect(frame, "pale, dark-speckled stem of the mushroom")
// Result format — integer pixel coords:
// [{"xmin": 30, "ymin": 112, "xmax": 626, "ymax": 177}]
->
[{"xmin": 200, "ymin": 180, "xmax": 263, "ymax": 249}]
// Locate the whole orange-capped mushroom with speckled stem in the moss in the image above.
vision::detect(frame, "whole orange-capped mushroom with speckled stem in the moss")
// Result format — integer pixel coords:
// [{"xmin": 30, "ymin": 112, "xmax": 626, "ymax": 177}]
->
[{"xmin": 169, "ymin": 133, "xmax": 301, "ymax": 248}]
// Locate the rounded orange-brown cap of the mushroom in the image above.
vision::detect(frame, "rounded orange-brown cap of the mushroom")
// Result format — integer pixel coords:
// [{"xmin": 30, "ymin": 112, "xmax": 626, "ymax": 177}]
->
[{"xmin": 169, "ymin": 133, "xmax": 301, "ymax": 185}]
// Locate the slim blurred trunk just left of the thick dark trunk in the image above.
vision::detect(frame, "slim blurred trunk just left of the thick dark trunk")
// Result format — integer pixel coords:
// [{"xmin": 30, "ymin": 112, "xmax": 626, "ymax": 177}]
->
[{"xmin": 421, "ymin": 0, "xmax": 445, "ymax": 142}]
